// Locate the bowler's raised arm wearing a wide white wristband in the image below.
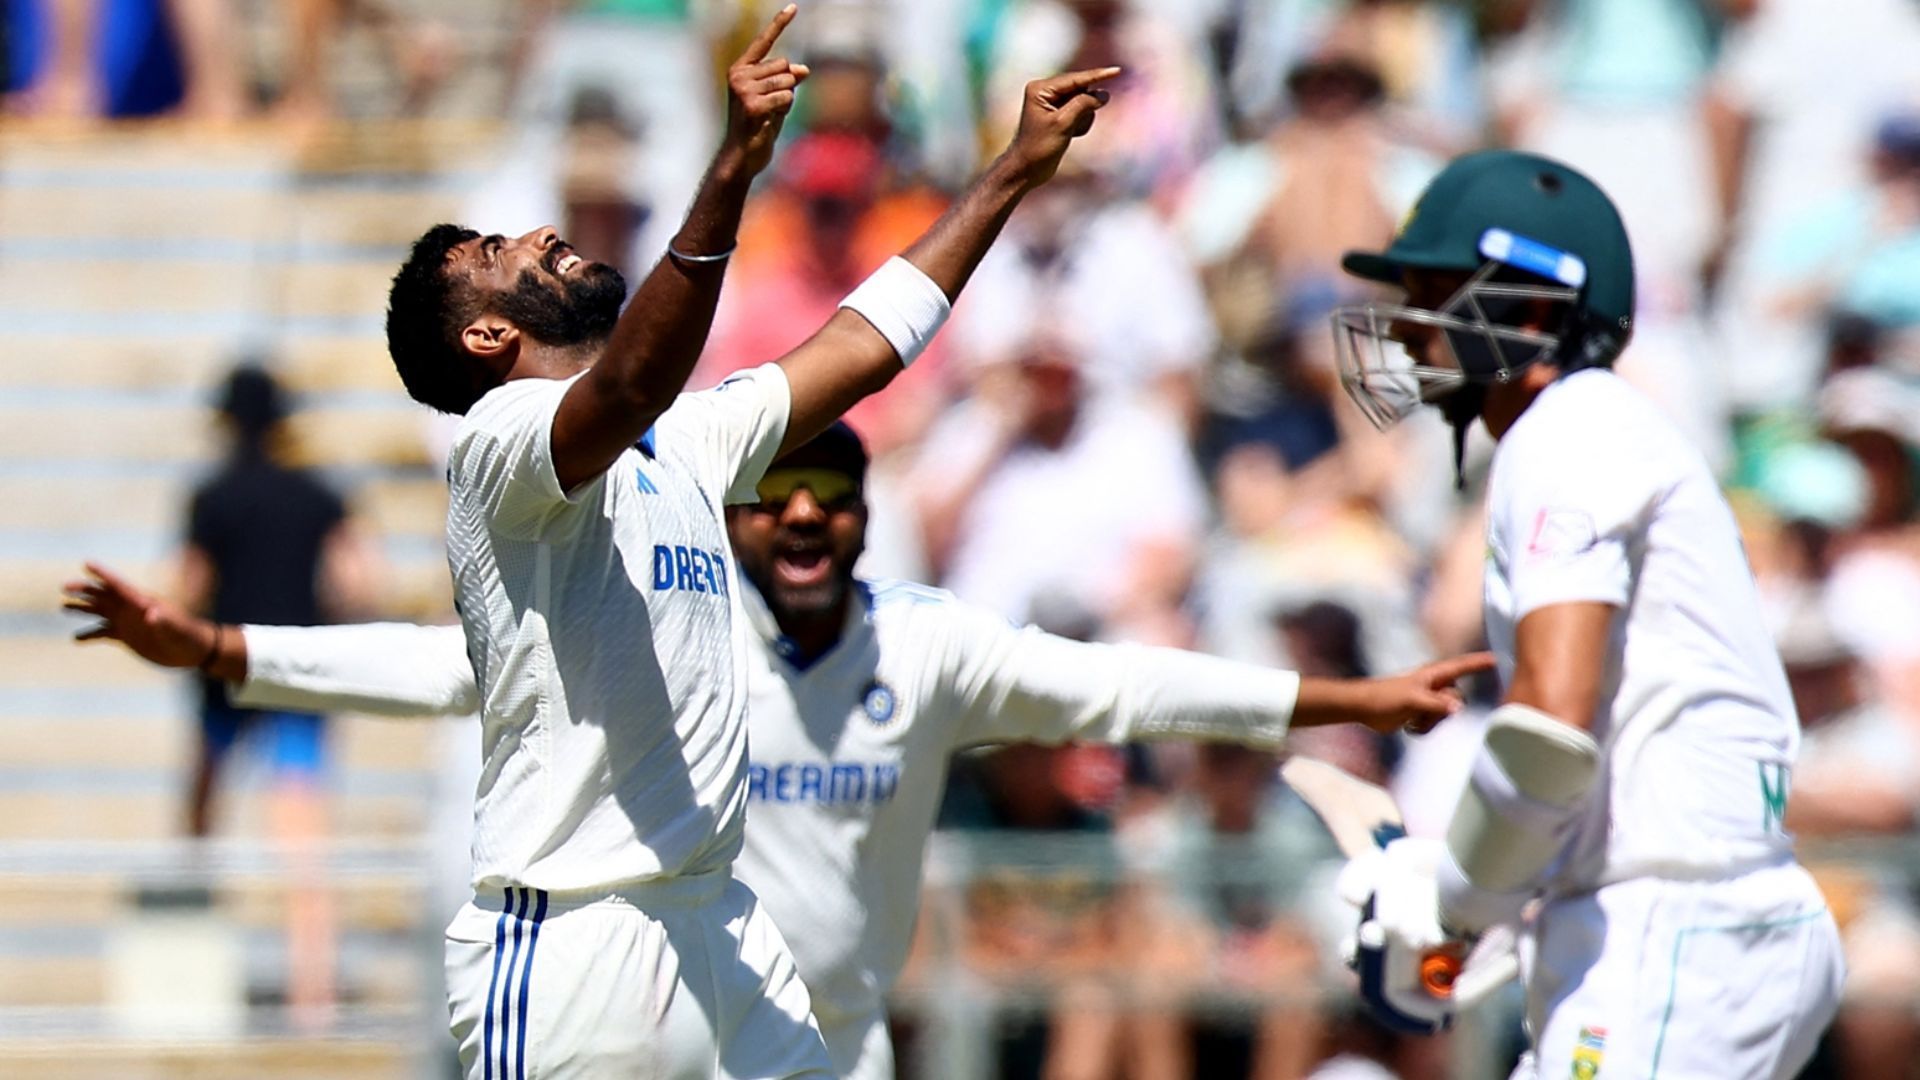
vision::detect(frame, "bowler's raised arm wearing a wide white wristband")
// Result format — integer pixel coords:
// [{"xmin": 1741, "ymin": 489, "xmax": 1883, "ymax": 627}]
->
[{"xmin": 780, "ymin": 67, "xmax": 1119, "ymax": 454}]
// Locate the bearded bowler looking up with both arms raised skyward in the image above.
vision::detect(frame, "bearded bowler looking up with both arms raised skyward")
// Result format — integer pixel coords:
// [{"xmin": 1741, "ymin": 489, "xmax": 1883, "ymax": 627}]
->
[{"xmin": 362, "ymin": 4, "xmax": 1119, "ymax": 1080}]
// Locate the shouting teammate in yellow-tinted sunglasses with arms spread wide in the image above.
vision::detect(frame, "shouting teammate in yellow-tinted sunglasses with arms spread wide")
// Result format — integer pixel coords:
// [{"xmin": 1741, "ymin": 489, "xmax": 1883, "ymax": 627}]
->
[{"xmin": 73, "ymin": 425, "xmax": 1490, "ymax": 1078}]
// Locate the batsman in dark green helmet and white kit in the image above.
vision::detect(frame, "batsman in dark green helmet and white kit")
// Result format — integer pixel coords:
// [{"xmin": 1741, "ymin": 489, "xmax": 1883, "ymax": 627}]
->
[{"xmin": 1334, "ymin": 152, "xmax": 1841, "ymax": 1078}]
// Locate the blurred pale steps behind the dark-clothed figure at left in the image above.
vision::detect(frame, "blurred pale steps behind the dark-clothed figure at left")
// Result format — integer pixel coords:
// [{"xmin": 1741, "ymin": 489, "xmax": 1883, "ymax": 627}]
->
[{"xmin": 0, "ymin": 115, "xmax": 495, "ymax": 1045}]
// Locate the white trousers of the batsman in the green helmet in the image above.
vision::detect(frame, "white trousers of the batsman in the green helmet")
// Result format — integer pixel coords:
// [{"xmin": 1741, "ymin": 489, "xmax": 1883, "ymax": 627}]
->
[{"xmin": 1513, "ymin": 863, "xmax": 1845, "ymax": 1080}]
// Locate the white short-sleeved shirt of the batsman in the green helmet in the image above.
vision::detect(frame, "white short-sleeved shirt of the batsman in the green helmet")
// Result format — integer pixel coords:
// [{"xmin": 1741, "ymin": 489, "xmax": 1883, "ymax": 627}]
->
[{"xmin": 1486, "ymin": 369, "xmax": 1799, "ymax": 892}]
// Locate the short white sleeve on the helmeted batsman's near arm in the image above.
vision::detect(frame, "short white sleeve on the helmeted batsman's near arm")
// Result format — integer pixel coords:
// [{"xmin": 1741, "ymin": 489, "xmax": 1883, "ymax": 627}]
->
[{"xmin": 1490, "ymin": 420, "xmax": 1661, "ymax": 621}]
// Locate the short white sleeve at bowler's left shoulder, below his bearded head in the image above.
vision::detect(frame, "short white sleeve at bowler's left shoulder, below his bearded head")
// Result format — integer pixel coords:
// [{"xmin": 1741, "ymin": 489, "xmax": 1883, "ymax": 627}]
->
[{"xmin": 447, "ymin": 379, "xmax": 601, "ymax": 538}]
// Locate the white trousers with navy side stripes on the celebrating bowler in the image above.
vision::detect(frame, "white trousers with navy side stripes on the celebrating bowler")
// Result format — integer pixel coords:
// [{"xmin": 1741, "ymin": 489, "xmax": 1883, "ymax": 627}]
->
[{"xmin": 447, "ymin": 874, "xmax": 833, "ymax": 1080}]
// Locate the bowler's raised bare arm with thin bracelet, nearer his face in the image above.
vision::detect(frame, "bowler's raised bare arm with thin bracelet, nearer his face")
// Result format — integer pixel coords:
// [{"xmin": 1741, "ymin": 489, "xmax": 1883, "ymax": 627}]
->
[{"xmin": 553, "ymin": 4, "xmax": 808, "ymax": 490}]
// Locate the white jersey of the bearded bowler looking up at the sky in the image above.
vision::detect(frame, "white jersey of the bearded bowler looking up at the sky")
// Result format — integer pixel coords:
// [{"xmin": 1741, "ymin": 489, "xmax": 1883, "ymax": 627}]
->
[{"xmin": 447, "ymin": 365, "xmax": 789, "ymax": 892}]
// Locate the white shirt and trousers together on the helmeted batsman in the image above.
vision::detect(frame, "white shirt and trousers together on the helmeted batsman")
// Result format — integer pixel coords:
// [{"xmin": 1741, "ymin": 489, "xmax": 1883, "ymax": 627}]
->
[{"xmin": 1486, "ymin": 371, "xmax": 1841, "ymax": 1080}]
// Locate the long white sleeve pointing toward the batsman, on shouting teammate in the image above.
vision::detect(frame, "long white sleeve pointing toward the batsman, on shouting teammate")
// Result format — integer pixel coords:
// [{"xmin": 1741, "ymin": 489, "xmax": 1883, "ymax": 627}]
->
[{"xmin": 916, "ymin": 588, "xmax": 1300, "ymax": 746}]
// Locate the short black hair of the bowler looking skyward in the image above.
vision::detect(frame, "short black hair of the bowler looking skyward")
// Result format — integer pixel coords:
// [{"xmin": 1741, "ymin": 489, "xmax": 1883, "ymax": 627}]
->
[{"xmin": 386, "ymin": 225, "xmax": 484, "ymax": 413}]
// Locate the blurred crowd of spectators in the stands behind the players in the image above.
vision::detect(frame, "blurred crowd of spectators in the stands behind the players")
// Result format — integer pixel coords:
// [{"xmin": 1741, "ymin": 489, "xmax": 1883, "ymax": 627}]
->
[{"xmin": 12, "ymin": 0, "xmax": 1920, "ymax": 1078}]
